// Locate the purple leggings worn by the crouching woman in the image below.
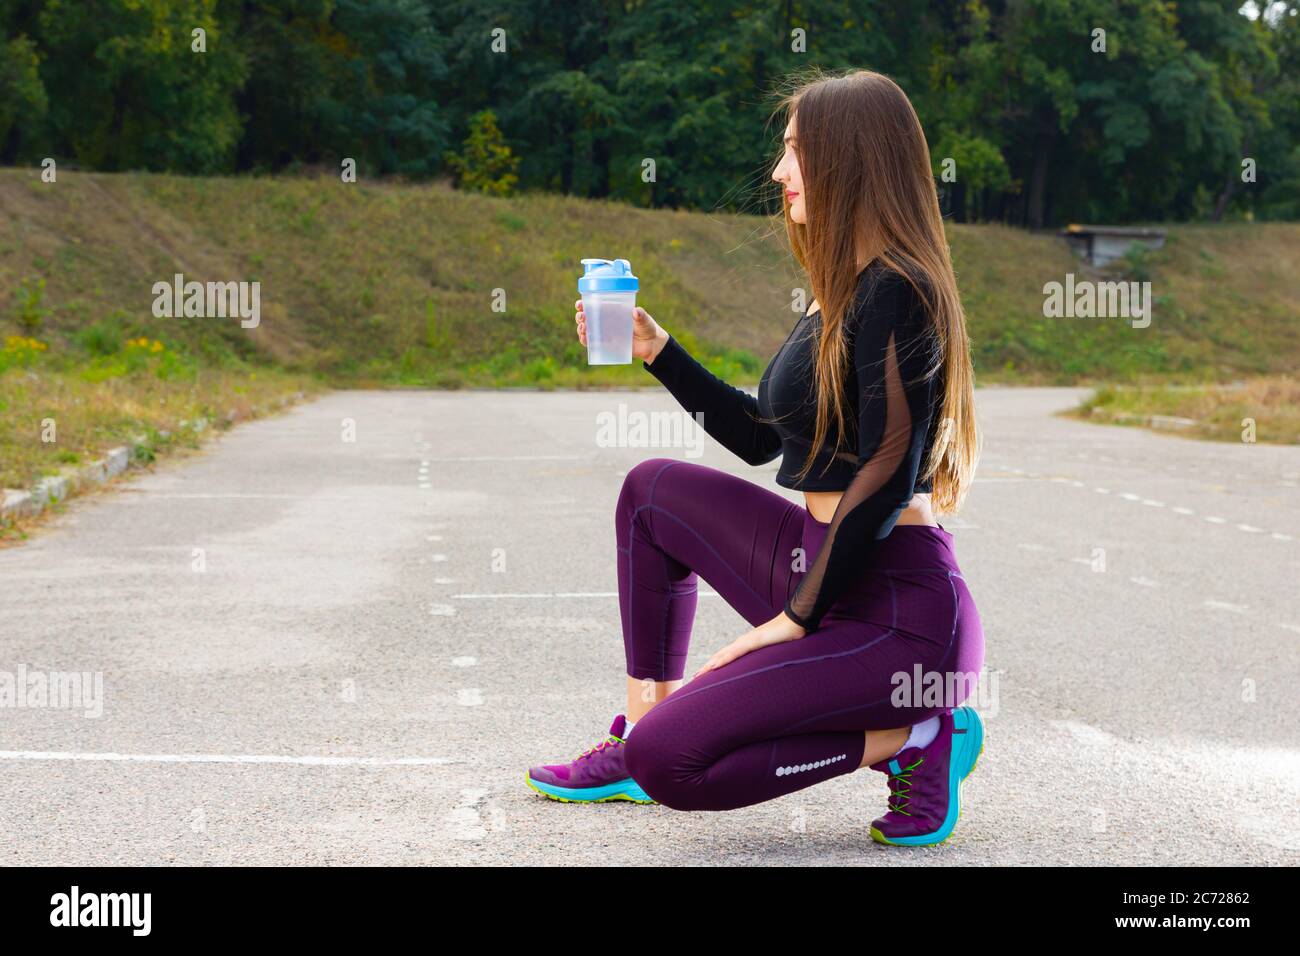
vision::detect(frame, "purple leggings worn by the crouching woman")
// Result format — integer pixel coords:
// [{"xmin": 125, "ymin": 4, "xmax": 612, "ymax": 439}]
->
[{"xmin": 618, "ymin": 458, "xmax": 984, "ymax": 810}]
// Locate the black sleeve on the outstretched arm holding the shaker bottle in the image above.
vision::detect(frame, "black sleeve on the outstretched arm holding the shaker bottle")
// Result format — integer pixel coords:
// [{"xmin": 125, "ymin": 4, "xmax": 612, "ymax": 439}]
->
[{"xmin": 641, "ymin": 336, "xmax": 781, "ymax": 464}]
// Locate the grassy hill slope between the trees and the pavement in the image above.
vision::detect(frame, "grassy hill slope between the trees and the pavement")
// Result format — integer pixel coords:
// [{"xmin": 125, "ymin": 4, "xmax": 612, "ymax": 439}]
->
[{"xmin": 0, "ymin": 169, "xmax": 1300, "ymax": 486}]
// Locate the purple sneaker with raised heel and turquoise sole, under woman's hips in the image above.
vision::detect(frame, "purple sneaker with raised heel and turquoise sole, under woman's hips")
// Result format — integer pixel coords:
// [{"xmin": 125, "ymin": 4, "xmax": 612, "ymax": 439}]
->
[{"xmin": 871, "ymin": 708, "xmax": 984, "ymax": 847}]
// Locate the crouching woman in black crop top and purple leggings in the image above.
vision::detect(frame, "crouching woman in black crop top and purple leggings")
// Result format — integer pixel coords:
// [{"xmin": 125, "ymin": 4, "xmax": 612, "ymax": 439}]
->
[{"xmin": 528, "ymin": 70, "xmax": 984, "ymax": 844}]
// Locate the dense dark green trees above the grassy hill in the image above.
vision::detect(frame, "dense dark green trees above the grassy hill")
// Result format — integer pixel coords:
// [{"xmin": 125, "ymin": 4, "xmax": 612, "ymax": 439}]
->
[{"xmin": 0, "ymin": 0, "xmax": 1300, "ymax": 226}]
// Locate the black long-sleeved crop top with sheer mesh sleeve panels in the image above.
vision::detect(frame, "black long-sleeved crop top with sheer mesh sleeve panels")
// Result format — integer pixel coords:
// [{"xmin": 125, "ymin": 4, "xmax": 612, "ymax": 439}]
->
[{"xmin": 641, "ymin": 261, "xmax": 943, "ymax": 632}]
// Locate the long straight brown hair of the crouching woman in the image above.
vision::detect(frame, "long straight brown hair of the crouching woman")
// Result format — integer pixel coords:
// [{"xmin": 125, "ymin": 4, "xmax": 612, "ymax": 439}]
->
[{"xmin": 768, "ymin": 70, "xmax": 980, "ymax": 514}]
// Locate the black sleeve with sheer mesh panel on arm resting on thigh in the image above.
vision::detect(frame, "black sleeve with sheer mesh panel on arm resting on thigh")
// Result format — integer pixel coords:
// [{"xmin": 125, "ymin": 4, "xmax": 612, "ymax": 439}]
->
[{"xmin": 785, "ymin": 278, "xmax": 932, "ymax": 632}]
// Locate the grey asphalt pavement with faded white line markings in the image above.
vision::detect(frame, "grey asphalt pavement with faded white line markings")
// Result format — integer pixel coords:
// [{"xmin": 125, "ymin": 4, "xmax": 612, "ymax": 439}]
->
[{"xmin": 0, "ymin": 388, "xmax": 1300, "ymax": 866}]
